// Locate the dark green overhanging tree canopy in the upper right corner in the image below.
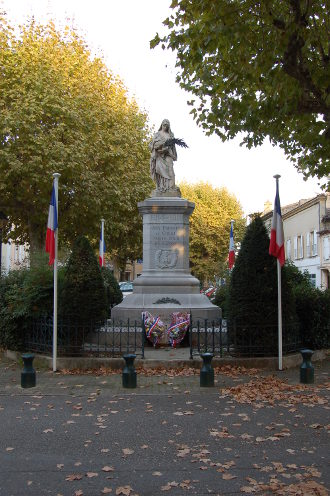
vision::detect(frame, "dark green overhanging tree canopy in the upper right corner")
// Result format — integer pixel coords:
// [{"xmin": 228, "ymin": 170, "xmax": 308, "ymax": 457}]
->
[{"xmin": 151, "ymin": 0, "xmax": 330, "ymax": 182}]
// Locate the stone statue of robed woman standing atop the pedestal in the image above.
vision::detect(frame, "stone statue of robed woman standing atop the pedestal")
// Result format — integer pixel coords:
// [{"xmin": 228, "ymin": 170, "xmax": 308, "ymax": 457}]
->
[{"xmin": 150, "ymin": 119, "xmax": 180, "ymax": 196}]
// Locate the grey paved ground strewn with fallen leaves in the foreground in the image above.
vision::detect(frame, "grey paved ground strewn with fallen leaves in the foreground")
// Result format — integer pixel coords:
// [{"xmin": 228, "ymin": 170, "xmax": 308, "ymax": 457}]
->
[{"xmin": 0, "ymin": 354, "xmax": 330, "ymax": 496}]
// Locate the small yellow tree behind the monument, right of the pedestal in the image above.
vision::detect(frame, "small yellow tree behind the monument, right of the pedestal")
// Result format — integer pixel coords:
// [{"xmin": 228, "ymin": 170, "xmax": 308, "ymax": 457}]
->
[{"xmin": 180, "ymin": 182, "xmax": 245, "ymax": 283}]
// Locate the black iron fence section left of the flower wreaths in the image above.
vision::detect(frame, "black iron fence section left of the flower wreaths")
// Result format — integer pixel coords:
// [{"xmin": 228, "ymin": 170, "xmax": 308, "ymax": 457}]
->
[{"xmin": 24, "ymin": 318, "xmax": 145, "ymax": 358}]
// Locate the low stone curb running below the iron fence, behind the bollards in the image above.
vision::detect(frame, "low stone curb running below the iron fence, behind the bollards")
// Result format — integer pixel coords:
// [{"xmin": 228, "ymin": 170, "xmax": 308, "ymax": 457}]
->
[{"xmin": 2, "ymin": 350, "xmax": 327, "ymax": 370}]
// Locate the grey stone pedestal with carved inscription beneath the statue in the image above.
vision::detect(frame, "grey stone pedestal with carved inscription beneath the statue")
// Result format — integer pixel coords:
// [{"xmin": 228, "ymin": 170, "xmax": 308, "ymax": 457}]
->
[{"xmin": 111, "ymin": 196, "xmax": 221, "ymax": 324}]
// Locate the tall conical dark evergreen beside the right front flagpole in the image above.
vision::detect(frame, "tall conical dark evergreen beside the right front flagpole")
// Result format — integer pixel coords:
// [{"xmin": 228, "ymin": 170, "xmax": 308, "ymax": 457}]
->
[{"xmin": 228, "ymin": 217, "xmax": 296, "ymax": 354}]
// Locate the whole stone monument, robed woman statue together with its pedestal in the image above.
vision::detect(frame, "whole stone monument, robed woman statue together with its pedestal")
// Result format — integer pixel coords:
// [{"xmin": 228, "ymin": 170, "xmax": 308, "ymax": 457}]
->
[{"xmin": 111, "ymin": 119, "xmax": 221, "ymax": 324}]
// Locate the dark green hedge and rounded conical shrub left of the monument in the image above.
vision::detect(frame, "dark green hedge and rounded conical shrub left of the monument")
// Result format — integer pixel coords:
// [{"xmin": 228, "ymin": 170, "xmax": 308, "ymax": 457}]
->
[{"xmin": 0, "ymin": 238, "xmax": 122, "ymax": 350}]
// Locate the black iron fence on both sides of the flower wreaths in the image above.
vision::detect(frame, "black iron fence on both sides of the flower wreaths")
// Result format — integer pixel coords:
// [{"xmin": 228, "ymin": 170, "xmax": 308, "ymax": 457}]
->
[{"xmin": 24, "ymin": 318, "xmax": 305, "ymax": 358}]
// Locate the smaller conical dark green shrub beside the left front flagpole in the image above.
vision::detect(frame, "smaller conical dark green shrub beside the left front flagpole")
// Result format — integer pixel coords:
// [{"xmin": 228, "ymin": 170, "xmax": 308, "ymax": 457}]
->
[{"xmin": 60, "ymin": 236, "xmax": 107, "ymax": 325}]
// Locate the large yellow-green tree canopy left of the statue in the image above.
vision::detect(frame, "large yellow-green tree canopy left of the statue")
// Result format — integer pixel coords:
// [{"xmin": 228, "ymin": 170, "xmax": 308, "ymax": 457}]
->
[{"xmin": 0, "ymin": 13, "xmax": 152, "ymax": 260}]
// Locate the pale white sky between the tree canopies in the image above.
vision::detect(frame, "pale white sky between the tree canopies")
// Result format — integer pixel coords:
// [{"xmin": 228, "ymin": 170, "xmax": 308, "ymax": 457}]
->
[{"xmin": 0, "ymin": 0, "xmax": 321, "ymax": 215}]
